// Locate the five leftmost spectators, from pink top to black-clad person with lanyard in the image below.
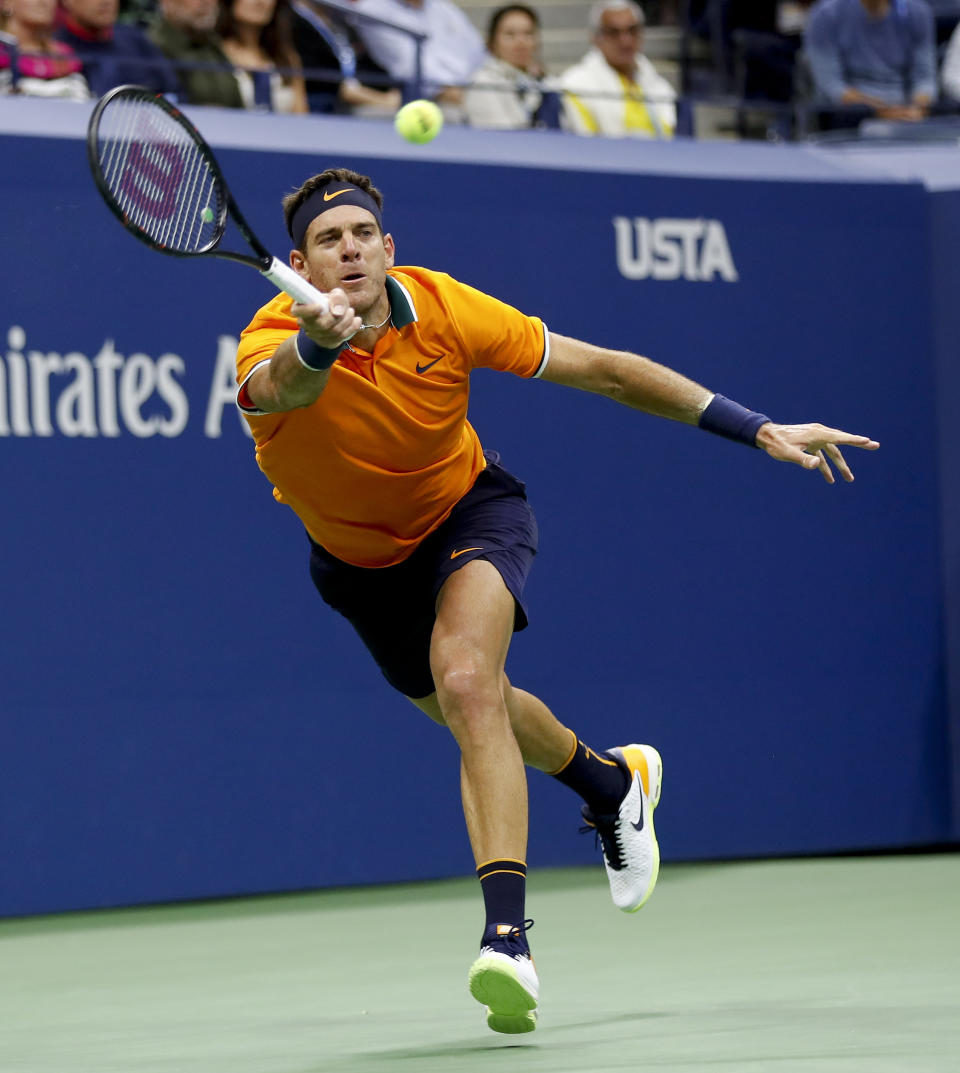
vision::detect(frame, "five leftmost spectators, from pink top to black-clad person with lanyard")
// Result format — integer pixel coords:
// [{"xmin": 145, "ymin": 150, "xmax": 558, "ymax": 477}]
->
[{"xmin": 0, "ymin": 0, "xmax": 405, "ymax": 114}]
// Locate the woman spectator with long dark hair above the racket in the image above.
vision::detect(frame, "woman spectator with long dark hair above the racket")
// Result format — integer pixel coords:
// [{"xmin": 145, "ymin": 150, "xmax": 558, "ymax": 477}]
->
[{"xmin": 217, "ymin": 0, "xmax": 309, "ymax": 113}]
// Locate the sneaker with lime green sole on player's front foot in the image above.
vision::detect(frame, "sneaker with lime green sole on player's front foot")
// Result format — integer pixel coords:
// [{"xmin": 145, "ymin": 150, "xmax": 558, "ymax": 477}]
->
[{"xmin": 470, "ymin": 921, "xmax": 540, "ymax": 1033}]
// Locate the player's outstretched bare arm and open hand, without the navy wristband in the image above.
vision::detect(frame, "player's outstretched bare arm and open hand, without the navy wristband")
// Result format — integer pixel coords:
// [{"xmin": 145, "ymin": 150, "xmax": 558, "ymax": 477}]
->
[{"xmin": 543, "ymin": 332, "xmax": 880, "ymax": 484}]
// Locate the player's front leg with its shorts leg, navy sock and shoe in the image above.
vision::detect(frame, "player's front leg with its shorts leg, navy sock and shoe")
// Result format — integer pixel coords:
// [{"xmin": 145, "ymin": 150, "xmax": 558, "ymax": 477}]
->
[{"xmin": 428, "ymin": 455, "xmax": 538, "ymax": 1032}]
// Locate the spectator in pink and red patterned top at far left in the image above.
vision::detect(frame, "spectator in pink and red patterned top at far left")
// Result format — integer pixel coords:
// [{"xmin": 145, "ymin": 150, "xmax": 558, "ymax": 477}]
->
[{"xmin": 0, "ymin": 0, "xmax": 90, "ymax": 101}]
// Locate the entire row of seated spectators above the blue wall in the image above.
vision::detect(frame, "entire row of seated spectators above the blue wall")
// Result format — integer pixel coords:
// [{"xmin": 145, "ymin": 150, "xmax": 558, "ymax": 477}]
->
[{"xmin": 0, "ymin": 0, "xmax": 960, "ymax": 138}]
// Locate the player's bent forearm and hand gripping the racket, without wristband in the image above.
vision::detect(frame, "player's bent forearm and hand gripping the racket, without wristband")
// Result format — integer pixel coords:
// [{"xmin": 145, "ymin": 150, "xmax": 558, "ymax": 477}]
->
[{"xmin": 247, "ymin": 289, "xmax": 361, "ymax": 413}]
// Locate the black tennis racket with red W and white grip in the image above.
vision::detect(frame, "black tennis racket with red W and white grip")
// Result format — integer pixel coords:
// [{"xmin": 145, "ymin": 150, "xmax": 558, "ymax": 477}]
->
[{"xmin": 87, "ymin": 86, "xmax": 327, "ymax": 309}]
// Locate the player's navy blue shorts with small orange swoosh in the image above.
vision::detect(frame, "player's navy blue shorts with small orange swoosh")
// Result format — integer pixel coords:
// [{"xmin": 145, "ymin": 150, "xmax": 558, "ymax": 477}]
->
[{"xmin": 310, "ymin": 452, "xmax": 538, "ymax": 700}]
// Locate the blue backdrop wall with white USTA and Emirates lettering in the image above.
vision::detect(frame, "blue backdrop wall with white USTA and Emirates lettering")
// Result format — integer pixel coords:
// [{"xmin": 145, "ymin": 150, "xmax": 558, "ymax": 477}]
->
[{"xmin": 0, "ymin": 101, "xmax": 960, "ymax": 914}]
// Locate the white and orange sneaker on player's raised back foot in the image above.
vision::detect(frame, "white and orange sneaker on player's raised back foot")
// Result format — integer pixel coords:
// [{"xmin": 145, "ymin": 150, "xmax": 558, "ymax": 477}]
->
[{"xmin": 580, "ymin": 745, "xmax": 663, "ymax": 913}]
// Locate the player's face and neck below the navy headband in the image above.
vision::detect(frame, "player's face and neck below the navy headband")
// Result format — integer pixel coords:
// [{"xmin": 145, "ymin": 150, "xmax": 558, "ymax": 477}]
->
[{"xmin": 291, "ymin": 205, "xmax": 394, "ymax": 317}]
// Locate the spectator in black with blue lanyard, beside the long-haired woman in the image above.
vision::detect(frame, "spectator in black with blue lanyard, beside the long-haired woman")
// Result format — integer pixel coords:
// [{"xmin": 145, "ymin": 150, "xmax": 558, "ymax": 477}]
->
[{"xmin": 292, "ymin": 0, "xmax": 402, "ymax": 115}]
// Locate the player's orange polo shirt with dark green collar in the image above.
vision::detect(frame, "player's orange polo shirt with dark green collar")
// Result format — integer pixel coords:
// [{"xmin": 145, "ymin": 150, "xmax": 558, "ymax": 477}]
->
[{"xmin": 237, "ymin": 267, "xmax": 548, "ymax": 567}]
